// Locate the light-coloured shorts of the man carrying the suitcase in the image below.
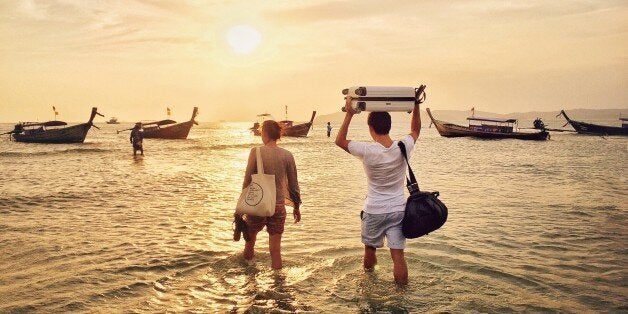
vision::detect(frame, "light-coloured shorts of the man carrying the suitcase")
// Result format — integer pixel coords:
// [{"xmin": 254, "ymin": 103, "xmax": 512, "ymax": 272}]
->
[{"xmin": 362, "ymin": 212, "xmax": 406, "ymax": 250}]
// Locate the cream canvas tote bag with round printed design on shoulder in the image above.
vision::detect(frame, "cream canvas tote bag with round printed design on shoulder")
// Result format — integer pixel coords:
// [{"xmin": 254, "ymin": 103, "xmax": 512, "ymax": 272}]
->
[{"xmin": 236, "ymin": 147, "xmax": 277, "ymax": 217}]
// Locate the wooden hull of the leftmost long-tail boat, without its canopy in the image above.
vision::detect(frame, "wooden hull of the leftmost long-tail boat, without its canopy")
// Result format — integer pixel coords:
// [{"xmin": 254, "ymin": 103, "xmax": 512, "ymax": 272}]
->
[{"xmin": 11, "ymin": 107, "xmax": 102, "ymax": 144}]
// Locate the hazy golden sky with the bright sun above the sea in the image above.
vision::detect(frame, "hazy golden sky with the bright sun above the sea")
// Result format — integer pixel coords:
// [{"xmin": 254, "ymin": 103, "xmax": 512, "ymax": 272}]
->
[{"xmin": 0, "ymin": 0, "xmax": 628, "ymax": 122}]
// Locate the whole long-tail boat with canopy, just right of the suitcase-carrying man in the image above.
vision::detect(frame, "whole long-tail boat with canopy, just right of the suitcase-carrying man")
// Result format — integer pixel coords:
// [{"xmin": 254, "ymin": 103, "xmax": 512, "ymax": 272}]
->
[{"xmin": 426, "ymin": 108, "xmax": 549, "ymax": 141}]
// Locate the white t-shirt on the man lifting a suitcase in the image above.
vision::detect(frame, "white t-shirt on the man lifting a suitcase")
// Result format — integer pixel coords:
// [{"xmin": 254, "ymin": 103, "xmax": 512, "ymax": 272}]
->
[{"xmin": 349, "ymin": 135, "xmax": 414, "ymax": 214}]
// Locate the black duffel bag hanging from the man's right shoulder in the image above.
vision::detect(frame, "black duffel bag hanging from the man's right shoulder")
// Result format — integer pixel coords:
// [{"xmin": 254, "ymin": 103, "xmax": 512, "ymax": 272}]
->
[{"xmin": 399, "ymin": 141, "xmax": 447, "ymax": 239}]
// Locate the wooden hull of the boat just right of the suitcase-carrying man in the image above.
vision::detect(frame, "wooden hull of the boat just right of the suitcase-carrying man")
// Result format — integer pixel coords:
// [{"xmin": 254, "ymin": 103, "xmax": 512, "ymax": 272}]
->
[{"xmin": 427, "ymin": 108, "xmax": 549, "ymax": 141}]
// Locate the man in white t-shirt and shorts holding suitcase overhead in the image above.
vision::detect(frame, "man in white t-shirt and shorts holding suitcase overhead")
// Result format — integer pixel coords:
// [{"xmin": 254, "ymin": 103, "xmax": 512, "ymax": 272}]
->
[{"xmin": 336, "ymin": 97, "xmax": 421, "ymax": 285}]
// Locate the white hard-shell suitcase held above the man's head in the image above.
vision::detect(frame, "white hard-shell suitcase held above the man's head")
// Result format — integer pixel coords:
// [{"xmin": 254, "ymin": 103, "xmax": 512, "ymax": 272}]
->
[{"xmin": 342, "ymin": 85, "xmax": 425, "ymax": 113}]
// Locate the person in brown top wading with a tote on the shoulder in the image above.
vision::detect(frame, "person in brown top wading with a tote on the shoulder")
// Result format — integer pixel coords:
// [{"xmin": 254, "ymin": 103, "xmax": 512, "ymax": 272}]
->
[{"xmin": 234, "ymin": 120, "xmax": 301, "ymax": 269}]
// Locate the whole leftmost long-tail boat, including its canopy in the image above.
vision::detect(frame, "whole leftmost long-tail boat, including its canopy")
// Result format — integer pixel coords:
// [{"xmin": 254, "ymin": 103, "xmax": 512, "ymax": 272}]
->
[{"xmin": 7, "ymin": 107, "xmax": 104, "ymax": 144}]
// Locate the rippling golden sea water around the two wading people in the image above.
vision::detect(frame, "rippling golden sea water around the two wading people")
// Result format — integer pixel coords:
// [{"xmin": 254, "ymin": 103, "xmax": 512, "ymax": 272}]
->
[{"xmin": 0, "ymin": 123, "xmax": 628, "ymax": 313}]
